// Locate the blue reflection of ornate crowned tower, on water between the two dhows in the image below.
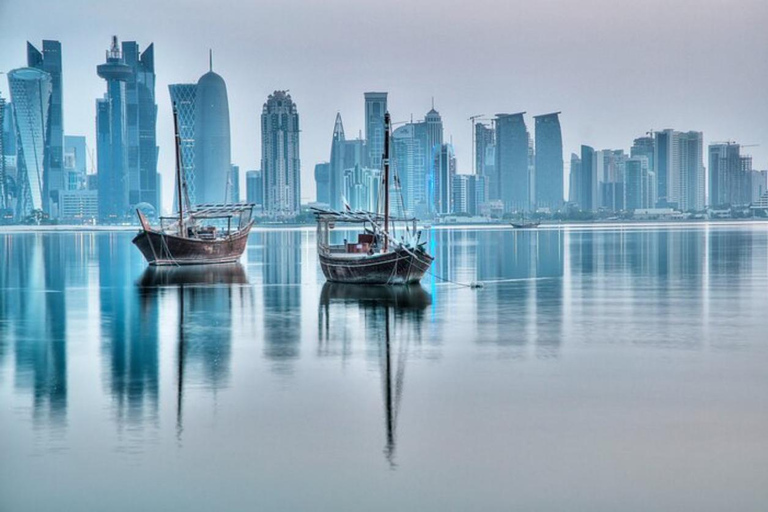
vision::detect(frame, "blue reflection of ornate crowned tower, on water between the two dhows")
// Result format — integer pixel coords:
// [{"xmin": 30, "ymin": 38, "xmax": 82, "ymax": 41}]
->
[{"xmin": 259, "ymin": 231, "xmax": 302, "ymax": 374}]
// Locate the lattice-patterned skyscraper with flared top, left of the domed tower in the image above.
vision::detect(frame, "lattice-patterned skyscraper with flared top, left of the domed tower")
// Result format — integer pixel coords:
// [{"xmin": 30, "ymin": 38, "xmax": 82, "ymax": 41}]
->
[{"xmin": 168, "ymin": 84, "xmax": 198, "ymax": 207}]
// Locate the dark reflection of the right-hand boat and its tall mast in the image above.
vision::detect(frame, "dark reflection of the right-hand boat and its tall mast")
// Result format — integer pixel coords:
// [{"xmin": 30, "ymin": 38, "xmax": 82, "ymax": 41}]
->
[{"xmin": 319, "ymin": 283, "xmax": 432, "ymax": 469}]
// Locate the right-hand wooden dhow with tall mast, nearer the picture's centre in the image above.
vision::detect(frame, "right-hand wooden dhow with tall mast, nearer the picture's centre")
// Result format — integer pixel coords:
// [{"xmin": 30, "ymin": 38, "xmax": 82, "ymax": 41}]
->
[{"xmin": 315, "ymin": 112, "xmax": 434, "ymax": 285}]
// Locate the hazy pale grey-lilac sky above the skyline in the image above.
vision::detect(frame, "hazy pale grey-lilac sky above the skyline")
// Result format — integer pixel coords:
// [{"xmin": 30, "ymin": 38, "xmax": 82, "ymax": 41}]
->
[{"xmin": 0, "ymin": 0, "xmax": 768, "ymax": 212}]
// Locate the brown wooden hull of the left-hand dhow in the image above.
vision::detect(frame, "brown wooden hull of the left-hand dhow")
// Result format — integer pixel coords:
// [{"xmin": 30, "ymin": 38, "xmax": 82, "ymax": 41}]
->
[{"xmin": 133, "ymin": 224, "xmax": 251, "ymax": 266}]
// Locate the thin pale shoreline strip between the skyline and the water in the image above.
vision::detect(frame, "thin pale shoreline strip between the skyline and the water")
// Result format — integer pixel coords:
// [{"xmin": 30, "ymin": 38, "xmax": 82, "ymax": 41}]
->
[{"xmin": 0, "ymin": 218, "xmax": 768, "ymax": 234}]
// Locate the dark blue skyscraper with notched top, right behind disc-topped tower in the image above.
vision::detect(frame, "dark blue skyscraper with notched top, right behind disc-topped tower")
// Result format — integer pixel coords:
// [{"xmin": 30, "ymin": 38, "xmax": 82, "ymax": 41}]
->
[{"xmin": 122, "ymin": 41, "xmax": 160, "ymax": 213}]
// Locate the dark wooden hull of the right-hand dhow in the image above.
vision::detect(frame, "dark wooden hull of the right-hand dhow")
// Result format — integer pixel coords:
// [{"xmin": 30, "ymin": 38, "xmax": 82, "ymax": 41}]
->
[{"xmin": 320, "ymin": 248, "xmax": 434, "ymax": 284}]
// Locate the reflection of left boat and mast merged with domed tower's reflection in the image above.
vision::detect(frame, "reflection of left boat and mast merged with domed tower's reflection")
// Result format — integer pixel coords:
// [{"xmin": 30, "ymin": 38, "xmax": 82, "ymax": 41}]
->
[{"xmin": 137, "ymin": 263, "xmax": 251, "ymax": 436}]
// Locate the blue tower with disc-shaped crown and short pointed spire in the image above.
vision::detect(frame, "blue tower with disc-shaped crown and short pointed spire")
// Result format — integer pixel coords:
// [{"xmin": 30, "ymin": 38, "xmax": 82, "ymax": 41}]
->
[{"xmin": 96, "ymin": 36, "xmax": 134, "ymax": 222}]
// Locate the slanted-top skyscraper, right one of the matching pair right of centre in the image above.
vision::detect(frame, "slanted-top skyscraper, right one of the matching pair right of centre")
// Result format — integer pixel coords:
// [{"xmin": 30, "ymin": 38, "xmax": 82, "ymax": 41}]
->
[{"xmin": 534, "ymin": 112, "xmax": 563, "ymax": 211}]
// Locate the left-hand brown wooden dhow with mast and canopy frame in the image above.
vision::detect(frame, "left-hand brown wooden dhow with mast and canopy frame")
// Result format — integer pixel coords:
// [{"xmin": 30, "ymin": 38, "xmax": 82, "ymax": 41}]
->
[{"xmin": 133, "ymin": 104, "xmax": 254, "ymax": 265}]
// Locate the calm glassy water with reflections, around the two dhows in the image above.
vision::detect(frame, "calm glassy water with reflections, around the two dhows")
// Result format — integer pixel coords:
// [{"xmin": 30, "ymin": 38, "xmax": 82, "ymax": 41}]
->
[{"xmin": 0, "ymin": 225, "xmax": 768, "ymax": 512}]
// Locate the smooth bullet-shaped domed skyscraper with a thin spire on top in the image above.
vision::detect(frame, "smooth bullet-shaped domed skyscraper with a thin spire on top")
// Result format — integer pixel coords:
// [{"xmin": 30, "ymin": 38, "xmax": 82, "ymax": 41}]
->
[{"xmin": 190, "ymin": 57, "xmax": 232, "ymax": 204}]
